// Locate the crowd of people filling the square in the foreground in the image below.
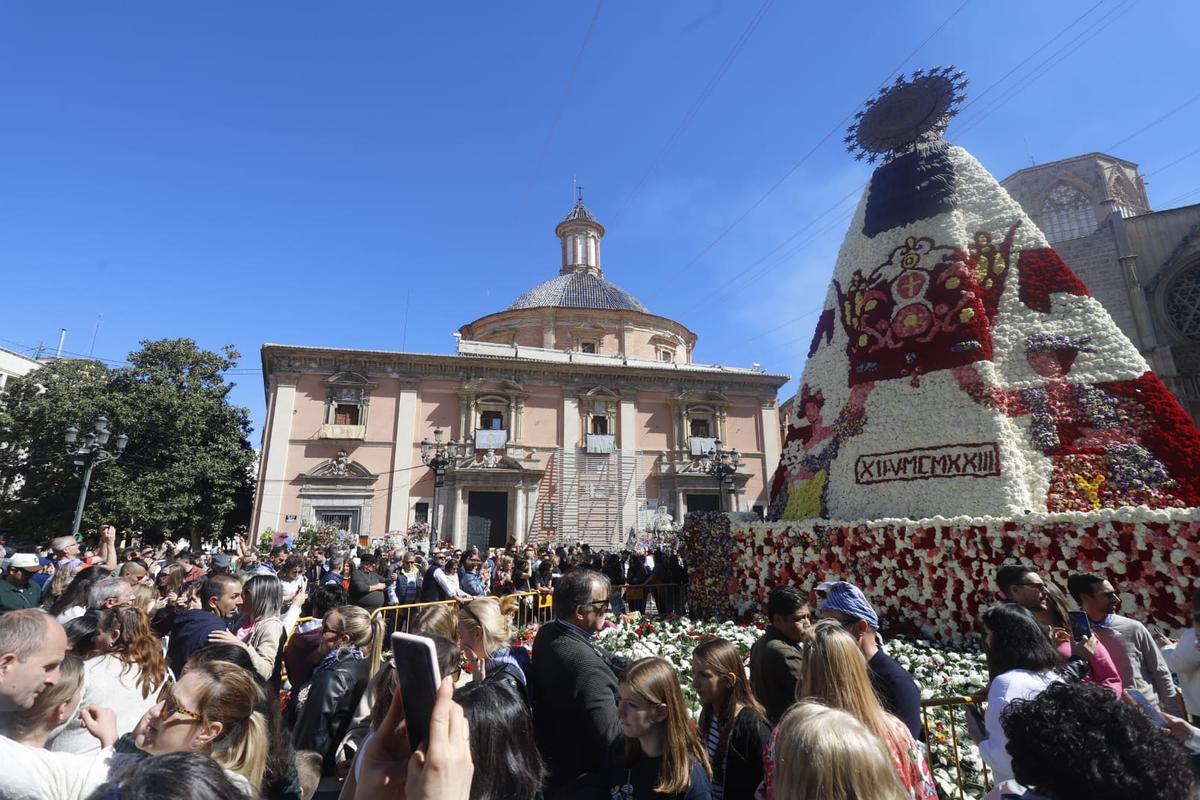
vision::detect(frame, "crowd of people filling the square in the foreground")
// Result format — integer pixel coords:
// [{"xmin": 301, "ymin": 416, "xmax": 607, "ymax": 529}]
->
[{"xmin": 0, "ymin": 527, "xmax": 1200, "ymax": 800}]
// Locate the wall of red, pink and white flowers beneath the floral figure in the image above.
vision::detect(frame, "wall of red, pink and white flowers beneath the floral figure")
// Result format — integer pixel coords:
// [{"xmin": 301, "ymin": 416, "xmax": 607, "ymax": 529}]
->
[{"xmin": 683, "ymin": 507, "xmax": 1200, "ymax": 640}]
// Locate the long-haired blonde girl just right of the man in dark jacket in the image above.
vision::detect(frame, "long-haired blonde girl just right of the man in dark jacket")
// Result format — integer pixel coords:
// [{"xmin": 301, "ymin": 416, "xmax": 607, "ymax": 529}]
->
[{"xmin": 611, "ymin": 657, "xmax": 712, "ymax": 800}]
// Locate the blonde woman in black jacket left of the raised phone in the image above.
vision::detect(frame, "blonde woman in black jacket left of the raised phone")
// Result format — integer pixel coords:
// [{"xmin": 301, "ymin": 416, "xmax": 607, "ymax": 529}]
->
[{"xmin": 289, "ymin": 606, "xmax": 388, "ymax": 775}]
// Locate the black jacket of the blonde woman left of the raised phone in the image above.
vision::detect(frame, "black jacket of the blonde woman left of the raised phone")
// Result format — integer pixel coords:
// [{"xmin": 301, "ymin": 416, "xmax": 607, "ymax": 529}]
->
[{"xmin": 292, "ymin": 658, "xmax": 368, "ymax": 775}]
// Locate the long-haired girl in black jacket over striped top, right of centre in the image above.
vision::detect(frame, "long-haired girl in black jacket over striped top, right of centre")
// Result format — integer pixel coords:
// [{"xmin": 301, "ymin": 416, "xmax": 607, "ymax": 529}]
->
[{"xmin": 691, "ymin": 639, "xmax": 770, "ymax": 800}]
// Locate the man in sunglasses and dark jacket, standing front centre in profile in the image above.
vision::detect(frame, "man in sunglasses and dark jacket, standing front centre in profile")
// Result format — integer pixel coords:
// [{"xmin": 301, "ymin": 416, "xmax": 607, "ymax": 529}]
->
[{"xmin": 529, "ymin": 569, "xmax": 620, "ymax": 800}]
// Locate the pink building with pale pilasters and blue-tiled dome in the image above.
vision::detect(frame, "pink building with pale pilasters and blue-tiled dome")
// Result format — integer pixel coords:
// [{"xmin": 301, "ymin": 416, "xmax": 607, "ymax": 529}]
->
[{"xmin": 252, "ymin": 203, "xmax": 787, "ymax": 547}]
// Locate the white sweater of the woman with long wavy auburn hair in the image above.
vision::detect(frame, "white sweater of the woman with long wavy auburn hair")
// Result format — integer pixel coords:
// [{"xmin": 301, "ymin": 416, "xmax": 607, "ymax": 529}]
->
[{"xmin": 46, "ymin": 655, "xmax": 158, "ymax": 753}]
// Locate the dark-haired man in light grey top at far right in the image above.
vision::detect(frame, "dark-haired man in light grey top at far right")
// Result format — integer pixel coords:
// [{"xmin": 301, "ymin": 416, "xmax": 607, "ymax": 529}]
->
[{"xmin": 1067, "ymin": 573, "xmax": 1183, "ymax": 716}]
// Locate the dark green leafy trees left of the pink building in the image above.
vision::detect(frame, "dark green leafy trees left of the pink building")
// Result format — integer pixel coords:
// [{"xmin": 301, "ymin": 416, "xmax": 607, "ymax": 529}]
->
[{"xmin": 0, "ymin": 338, "xmax": 254, "ymax": 542}]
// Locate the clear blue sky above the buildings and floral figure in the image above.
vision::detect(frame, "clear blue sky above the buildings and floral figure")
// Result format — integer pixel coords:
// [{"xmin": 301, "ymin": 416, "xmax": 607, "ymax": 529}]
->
[{"xmin": 0, "ymin": 0, "xmax": 1200, "ymax": 446}]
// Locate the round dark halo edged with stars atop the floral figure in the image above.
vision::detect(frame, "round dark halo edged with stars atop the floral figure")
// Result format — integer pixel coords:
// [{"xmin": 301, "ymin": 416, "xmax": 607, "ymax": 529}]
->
[{"xmin": 842, "ymin": 66, "xmax": 967, "ymax": 164}]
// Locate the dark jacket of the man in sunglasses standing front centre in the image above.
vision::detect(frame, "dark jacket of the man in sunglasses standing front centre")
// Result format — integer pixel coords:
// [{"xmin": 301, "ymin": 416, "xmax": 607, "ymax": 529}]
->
[{"xmin": 529, "ymin": 621, "xmax": 620, "ymax": 799}]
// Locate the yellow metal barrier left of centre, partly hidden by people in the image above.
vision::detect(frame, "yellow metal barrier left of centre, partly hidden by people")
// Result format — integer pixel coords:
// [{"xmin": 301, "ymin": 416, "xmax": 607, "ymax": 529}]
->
[{"xmin": 371, "ymin": 583, "xmax": 686, "ymax": 632}]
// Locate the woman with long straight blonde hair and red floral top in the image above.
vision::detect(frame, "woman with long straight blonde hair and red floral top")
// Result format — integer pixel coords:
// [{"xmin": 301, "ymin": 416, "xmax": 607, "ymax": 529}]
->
[{"xmin": 792, "ymin": 620, "xmax": 937, "ymax": 800}]
